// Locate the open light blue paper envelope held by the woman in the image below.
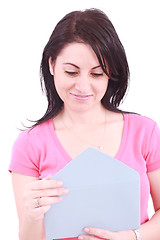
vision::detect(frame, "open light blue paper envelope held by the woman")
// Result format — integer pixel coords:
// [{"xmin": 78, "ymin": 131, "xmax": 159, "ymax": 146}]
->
[{"xmin": 45, "ymin": 148, "xmax": 140, "ymax": 240}]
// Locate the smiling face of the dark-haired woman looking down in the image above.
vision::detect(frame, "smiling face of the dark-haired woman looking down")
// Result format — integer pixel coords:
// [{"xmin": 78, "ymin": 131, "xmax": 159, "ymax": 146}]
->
[{"xmin": 49, "ymin": 42, "xmax": 108, "ymax": 111}]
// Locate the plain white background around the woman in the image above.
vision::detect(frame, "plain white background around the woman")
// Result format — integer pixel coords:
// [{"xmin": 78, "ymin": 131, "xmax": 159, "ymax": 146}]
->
[{"xmin": 0, "ymin": 0, "xmax": 160, "ymax": 240}]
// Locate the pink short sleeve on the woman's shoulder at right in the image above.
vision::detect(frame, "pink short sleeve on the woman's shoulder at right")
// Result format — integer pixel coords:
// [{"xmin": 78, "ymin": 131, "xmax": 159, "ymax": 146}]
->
[{"xmin": 146, "ymin": 123, "xmax": 160, "ymax": 172}]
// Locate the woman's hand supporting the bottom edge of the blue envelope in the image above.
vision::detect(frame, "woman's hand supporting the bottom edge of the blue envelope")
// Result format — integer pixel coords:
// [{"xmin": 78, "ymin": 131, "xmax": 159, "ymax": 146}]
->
[{"xmin": 78, "ymin": 227, "xmax": 136, "ymax": 240}]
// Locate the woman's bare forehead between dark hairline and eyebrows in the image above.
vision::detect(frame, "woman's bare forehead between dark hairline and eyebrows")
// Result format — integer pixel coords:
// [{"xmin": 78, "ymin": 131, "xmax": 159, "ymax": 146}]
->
[{"xmin": 56, "ymin": 42, "xmax": 99, "ymax": 66}]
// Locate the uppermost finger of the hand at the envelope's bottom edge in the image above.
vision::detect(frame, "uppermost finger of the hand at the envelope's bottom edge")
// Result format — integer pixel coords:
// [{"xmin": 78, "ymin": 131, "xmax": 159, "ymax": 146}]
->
[{"xmin": 84, "ymin": 227, "xmax": 113, "ymax": 239}]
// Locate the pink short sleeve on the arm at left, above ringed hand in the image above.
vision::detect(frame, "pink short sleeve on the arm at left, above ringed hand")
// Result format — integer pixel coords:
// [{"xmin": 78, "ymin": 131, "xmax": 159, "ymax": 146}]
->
[{"xmin": 8, "ymin": 131, "xmax": 39, "ymax": 177}]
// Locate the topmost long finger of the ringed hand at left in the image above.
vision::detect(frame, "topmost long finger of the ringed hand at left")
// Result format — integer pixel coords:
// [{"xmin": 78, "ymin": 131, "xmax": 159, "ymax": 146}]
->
[{"xmin": 31, "ymin": 180, "xmax": 63, "ymax": 190}]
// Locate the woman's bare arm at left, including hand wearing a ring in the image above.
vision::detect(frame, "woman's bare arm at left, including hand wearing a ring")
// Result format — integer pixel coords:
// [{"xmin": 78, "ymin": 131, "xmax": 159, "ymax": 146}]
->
[{"xmin": 12, "ymin": 172, "xmax": 66, "ymax": 240}]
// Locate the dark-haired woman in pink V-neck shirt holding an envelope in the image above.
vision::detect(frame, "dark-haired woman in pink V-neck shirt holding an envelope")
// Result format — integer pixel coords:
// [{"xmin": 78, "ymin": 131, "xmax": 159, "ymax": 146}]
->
[{"xmin": 9, "ymin": 9, "xmax": 160, "ymax": 240}]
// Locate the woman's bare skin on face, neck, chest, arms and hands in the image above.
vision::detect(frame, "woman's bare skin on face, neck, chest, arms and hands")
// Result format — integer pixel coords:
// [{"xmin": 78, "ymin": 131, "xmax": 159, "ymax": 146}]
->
[{"xmin": 12, "ymin": 43, "xmax": 160, "ymax": 240}]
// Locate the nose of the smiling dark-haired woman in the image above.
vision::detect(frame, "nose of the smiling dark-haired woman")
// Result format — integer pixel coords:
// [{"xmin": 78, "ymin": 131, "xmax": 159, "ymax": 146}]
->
[{"xmin": 75, "ymin": 75, "xmax": 91, "ymax": 93}]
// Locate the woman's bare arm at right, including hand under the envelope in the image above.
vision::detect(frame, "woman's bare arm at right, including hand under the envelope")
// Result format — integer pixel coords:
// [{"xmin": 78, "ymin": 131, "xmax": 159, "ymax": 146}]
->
[{"xmin": 79, "ymin": 169, "xmax": 160, "ymax": 240}]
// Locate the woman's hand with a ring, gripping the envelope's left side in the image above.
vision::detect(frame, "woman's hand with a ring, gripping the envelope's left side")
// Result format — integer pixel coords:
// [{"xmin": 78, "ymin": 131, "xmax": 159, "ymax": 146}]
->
[{"xmin": 23, "ymin": 175, "xmax": 68, "ymax": 221}]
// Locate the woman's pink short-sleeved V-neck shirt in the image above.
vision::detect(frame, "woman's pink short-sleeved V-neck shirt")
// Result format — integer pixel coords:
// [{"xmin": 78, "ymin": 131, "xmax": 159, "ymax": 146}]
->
[{"xmin": 9, "ymin": 113, "xmax": 160, "ymax": 224}]
